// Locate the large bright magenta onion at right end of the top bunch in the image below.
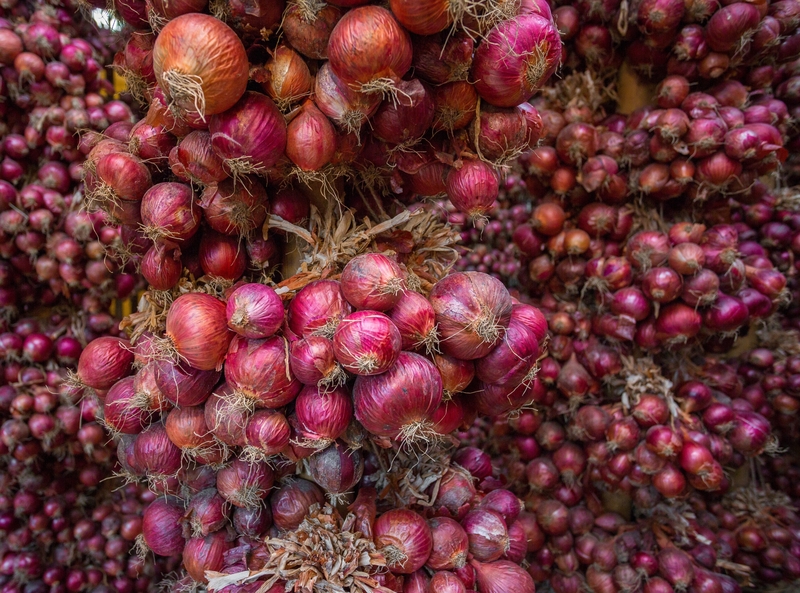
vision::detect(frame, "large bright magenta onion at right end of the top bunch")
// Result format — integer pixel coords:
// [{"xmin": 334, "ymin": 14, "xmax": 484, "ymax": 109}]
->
[{"xmin": 471, "ymin": 14, "xmax": 561, "ymax": 107}]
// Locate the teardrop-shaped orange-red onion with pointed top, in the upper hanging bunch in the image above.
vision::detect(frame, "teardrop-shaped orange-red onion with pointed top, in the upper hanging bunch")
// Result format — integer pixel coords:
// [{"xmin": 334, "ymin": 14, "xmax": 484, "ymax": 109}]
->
[{"xmin": 286, "ymin": 99, "xmax": 336, "ymax": 171}]
